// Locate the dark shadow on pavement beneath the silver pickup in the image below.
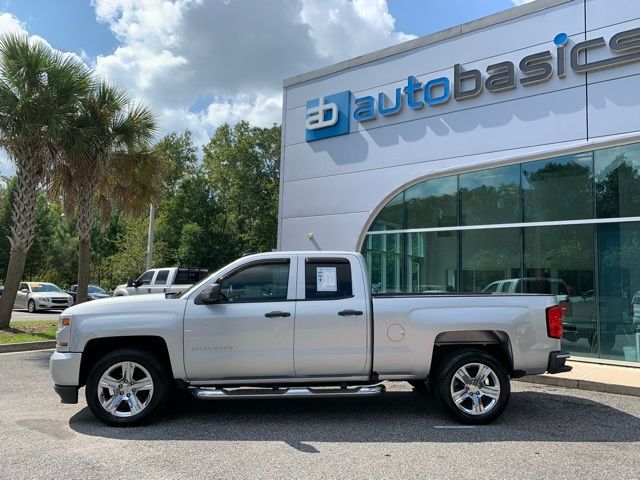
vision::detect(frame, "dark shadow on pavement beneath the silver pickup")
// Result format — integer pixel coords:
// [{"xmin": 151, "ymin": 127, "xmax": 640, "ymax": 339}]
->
[{"xmin": 69, "ymin": 387, "xmax": 640, "ymax": 453}]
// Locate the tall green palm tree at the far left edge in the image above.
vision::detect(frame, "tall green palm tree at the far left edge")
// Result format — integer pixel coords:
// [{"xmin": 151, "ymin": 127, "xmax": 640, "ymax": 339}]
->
[{"xmin": 0, "ymin": 34, "xmax": 92, "ymax": 329}]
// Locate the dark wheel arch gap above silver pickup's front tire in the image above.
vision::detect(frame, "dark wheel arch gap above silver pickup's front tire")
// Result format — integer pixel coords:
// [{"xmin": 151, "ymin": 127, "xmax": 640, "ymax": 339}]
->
[{"xmin": 79, "ymin": 335, "xmax": 173, "ymax": 386}]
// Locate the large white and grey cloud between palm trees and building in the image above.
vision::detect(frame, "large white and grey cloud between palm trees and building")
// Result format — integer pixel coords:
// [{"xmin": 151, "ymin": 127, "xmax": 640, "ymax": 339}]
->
[{"xmin": 93, "ymin": 0, "xmax": 413, "ymax": 143}]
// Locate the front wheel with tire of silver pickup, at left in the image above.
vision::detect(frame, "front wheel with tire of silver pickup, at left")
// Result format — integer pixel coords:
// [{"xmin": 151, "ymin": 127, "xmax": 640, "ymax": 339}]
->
[{"xmin": 85, "ymin": 349, "xmax": 171, "ymax": 426}]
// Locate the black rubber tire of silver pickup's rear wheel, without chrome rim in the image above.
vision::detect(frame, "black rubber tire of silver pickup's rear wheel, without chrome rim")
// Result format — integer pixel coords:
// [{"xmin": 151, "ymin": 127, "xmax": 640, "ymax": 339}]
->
[{"xmin": 433, "ymin": 350, "xmax": 511, "ymax": 425}]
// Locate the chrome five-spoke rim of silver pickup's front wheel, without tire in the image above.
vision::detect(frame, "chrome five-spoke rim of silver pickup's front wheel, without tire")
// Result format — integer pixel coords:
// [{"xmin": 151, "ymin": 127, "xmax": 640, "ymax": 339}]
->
[{"xmin": 98, "ymin": 362, "xmax": 153, "ymax": 417}]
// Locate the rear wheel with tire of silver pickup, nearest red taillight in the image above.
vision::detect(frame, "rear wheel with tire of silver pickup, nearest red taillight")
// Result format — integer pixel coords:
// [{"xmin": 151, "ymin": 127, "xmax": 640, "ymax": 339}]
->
[{"xmin": 434, "ymin": 350, "xmax": 511, "ymax": 425}]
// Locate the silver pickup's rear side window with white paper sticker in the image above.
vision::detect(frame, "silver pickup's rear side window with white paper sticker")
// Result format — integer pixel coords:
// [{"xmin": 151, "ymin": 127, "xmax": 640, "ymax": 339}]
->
[{"xmin": 304, "ymin": 258, "xmax": 353, "ymax": 300}]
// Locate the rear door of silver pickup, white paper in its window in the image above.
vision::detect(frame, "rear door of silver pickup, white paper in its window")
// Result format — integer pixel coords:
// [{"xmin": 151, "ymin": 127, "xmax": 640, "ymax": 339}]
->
[{"xmin": 294, "ymin": 256, "xmax": 369, "ymax": 377}]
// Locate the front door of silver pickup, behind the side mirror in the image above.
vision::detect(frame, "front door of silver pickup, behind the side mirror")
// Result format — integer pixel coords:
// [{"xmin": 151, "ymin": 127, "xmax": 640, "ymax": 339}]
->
[{"xmin": 184, "ymin": 255, "xmax": 297, "ymax": 380}]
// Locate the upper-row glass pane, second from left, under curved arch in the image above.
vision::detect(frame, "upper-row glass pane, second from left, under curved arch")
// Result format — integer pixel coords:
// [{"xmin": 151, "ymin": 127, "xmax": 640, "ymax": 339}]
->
[{"xmin": 404, "ymin": 176, "xmax": 458, "ymax": 228}]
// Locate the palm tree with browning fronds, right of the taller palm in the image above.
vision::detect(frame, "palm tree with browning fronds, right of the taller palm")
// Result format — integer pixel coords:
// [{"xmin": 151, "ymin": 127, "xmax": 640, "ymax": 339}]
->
[{"xmin": 53, "ymin": 83, "xmax": 164, "ymax": 302}]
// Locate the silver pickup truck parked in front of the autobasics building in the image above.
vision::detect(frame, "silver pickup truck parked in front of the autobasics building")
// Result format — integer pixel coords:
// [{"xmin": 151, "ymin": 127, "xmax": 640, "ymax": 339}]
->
[{"xmin": 50, "ymin": 252, "xmax": 570, "ymax": 425}]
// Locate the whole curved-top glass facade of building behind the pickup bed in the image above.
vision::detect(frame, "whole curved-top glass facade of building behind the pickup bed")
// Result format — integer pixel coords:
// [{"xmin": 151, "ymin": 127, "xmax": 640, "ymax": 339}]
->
[{"xmin": 362, "ymin": 144, "xmax": 640, "ymax": 362}]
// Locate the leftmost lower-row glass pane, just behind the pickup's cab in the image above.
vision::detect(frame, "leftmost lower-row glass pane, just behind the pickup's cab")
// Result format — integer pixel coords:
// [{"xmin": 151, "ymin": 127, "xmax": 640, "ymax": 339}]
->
[{"xmin": 362, "ymin": 233, "xmax": 403, "ymax": 294}]
